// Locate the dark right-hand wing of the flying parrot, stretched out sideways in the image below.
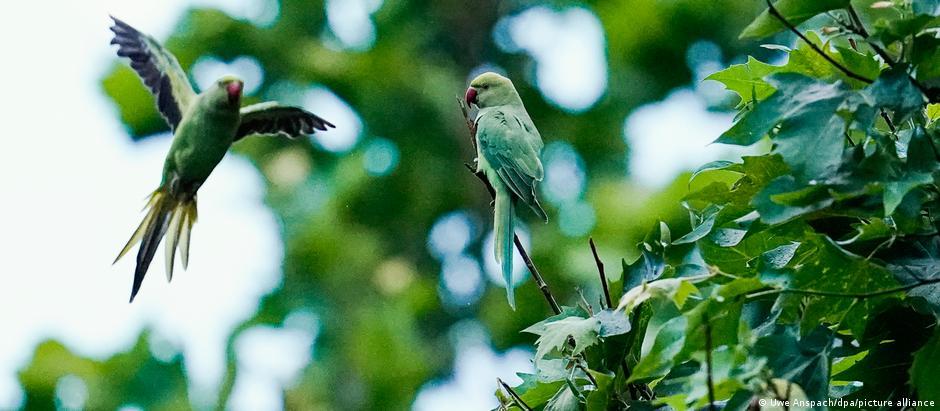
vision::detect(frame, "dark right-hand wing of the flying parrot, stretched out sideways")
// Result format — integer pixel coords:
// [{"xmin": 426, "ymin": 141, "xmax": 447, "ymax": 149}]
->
[{"xmin": 235, "ymin": 101, "xmax": 336, "ymax": 141}]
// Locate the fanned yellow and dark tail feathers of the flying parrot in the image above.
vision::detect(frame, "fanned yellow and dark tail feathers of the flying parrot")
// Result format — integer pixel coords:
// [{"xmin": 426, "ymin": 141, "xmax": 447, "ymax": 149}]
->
[{"xmin": 114, "ymin": 188, "xmax": 196, "ymax": 302}]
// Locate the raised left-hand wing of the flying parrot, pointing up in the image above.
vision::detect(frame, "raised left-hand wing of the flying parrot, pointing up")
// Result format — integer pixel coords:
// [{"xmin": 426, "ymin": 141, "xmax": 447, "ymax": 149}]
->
[{"xmin": 111, "ymin": 16, "xmax": 196, "ymax": 130}]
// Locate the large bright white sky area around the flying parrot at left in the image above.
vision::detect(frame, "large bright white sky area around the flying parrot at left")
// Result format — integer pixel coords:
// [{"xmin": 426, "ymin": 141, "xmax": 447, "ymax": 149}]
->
[{"xmin": 0, "ymin": 0, "xmax": 282, "ymax": 408}]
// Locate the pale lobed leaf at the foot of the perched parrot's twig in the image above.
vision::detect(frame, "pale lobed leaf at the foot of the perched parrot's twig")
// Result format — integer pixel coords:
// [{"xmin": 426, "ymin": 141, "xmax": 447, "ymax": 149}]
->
[{"xmin": 522, "ymin": 317, "xmax": 601, "ymax": 361}]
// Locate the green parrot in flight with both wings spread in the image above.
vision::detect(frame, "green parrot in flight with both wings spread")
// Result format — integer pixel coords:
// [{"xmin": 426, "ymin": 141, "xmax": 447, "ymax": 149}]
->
[{"xmin": 111, "ymin": 16, "xmax": 334, "ymax": 302}]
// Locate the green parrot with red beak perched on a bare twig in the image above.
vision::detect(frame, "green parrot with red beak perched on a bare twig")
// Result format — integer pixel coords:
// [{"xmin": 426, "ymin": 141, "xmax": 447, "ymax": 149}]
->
[{"xmin": 466, "ymin": 73, "xmax": 548, "ymax": 309}]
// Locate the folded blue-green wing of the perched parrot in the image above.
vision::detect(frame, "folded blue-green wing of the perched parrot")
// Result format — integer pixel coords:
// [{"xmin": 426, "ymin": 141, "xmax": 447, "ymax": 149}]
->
[{"xmin": 477, "ymin": 108, "xmax": 548, "ymax": 221}]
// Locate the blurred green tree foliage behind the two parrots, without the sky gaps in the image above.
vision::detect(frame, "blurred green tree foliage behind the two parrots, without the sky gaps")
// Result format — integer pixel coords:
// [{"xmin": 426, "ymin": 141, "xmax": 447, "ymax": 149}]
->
[{"xmin": 21, "ymin": 0, "xmax": 767, "ymax": 410}]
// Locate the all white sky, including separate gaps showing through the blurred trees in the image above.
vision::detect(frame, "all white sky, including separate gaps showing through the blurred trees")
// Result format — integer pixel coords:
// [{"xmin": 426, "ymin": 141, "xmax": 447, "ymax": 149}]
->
[{"xmin": 0, "ymin": 0, "xmax": 730, "ymax": 409}]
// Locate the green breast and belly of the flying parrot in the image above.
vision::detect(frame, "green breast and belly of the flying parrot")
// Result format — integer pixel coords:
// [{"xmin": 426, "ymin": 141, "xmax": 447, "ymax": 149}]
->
[{"xmin": 163, "ymin": 96, "xmax": 239, "ymax": 195}]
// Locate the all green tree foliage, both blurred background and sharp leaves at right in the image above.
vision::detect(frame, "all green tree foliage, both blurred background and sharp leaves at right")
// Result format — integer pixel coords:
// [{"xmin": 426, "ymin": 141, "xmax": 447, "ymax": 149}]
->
[{"xmin": 19, "ymin": 0, "xmax": 940, "ymax": 410}]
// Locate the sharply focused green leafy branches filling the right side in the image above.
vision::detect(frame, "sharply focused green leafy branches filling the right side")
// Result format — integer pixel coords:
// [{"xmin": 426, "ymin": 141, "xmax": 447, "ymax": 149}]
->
[{"xmin": 499, "ymin": 0, "xmax": 940, "ymax": 410}]
